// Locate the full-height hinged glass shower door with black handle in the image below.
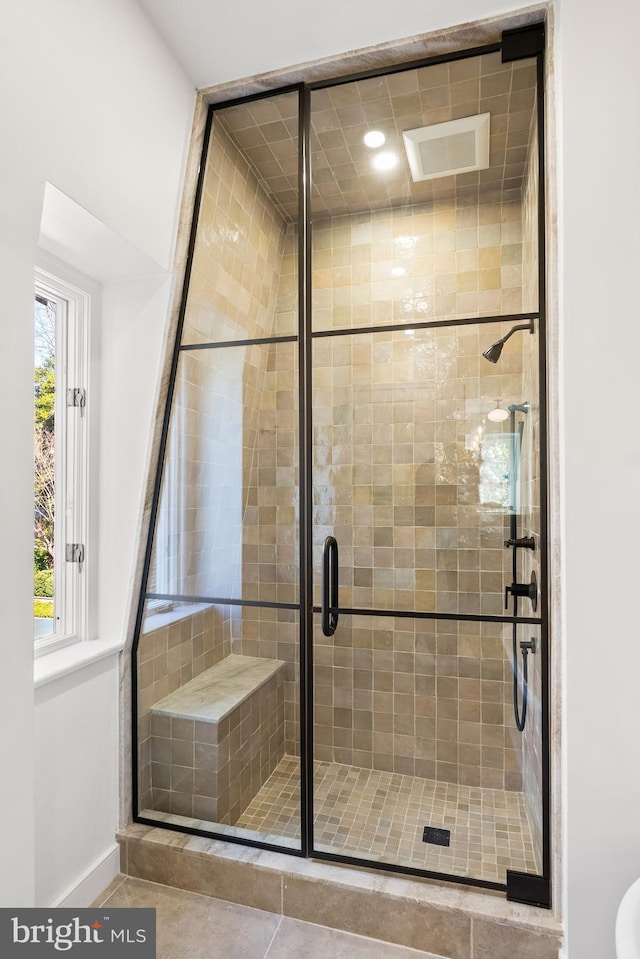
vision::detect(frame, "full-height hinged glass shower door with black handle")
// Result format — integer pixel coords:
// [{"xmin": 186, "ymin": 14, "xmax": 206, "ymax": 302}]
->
[{"xmin": 310, "ymin": 53, "xmax": 546, "ymax": 888}]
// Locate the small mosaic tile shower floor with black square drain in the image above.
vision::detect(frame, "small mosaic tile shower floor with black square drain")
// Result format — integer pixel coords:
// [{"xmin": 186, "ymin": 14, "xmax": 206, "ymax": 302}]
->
[{"xmin": 236, "ymin": 756, "xmax": 540, "ymax": 882}]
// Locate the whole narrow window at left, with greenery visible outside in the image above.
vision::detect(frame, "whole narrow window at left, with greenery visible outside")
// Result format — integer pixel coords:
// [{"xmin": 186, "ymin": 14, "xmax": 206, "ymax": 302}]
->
[{"xmin": 34, "ymin": 270, "xmax": 90, "ymax": 653}]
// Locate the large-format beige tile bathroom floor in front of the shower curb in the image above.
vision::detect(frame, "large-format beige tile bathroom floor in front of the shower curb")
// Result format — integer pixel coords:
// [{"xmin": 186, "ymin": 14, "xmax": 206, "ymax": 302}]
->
[{"xmin": 94, "ymin": 876, "xmax": 436, "ymax": 959}]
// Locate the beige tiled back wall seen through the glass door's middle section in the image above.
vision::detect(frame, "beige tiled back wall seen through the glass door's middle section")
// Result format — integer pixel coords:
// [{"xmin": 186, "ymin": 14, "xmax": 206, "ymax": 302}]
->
[{"xmin": 314, "ymin": 324, "xmax": 520, "ymax": 614}]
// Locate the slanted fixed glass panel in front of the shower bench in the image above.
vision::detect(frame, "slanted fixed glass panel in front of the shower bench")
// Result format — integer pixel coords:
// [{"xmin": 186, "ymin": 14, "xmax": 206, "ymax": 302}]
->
[{"xmin": 138, "ymin": 93, "xmax": 301, "ymax": 850}]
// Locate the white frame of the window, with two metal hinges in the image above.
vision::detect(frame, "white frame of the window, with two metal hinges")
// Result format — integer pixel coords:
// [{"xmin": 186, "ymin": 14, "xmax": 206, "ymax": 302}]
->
[{"xmin": 34, "ymin": 267, "xmax": 91, "ymax": 656}]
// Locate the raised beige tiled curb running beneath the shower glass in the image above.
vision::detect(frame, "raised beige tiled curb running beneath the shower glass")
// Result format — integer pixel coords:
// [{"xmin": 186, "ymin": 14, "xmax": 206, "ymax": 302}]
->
[{"xmin": 118, "ymin": 823, "xmax": 561, "ymax": 959}]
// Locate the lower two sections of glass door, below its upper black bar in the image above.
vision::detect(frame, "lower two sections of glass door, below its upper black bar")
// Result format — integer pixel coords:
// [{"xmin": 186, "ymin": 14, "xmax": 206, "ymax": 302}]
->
[{"xmin": 313, "ymin": 324, "xmax": 540, "ymax": 884}]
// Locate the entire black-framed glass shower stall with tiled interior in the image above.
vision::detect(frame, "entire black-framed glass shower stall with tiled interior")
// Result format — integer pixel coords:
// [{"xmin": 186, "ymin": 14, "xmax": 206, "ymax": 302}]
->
[{"xmin": 133, "ymin": 25, "xmax": 550, "ymax": 905}]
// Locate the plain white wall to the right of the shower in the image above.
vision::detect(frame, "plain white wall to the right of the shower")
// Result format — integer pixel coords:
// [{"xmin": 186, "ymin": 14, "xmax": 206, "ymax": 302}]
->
[{"xmin": 558, "ymin": 0, "xmax": 640, "ymax": 959}]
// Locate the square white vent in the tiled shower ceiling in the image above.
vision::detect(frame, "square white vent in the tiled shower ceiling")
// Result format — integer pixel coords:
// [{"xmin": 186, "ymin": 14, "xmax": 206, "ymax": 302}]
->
[{"xmin": 402, "ymin": 113, "xmax": 491, "ymax": 182}]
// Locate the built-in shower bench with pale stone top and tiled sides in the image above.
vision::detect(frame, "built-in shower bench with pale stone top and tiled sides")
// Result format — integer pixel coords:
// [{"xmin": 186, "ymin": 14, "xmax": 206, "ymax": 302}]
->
[{"xmin": 149, "ymin": 654, "xmax": 285, "ymax": 825}]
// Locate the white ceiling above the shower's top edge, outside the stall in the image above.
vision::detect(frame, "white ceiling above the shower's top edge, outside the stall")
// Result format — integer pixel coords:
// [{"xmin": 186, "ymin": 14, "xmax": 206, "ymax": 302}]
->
[{"xmin": 138, "ymin": 0, "xmax": 513, "ymax": 89}]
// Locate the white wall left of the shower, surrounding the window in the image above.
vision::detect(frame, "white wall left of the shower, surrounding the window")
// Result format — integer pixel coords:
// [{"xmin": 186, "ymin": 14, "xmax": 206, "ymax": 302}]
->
[{"xmin": 0, "ymin": 0, "xmax": 194, "ymax": 906}]
